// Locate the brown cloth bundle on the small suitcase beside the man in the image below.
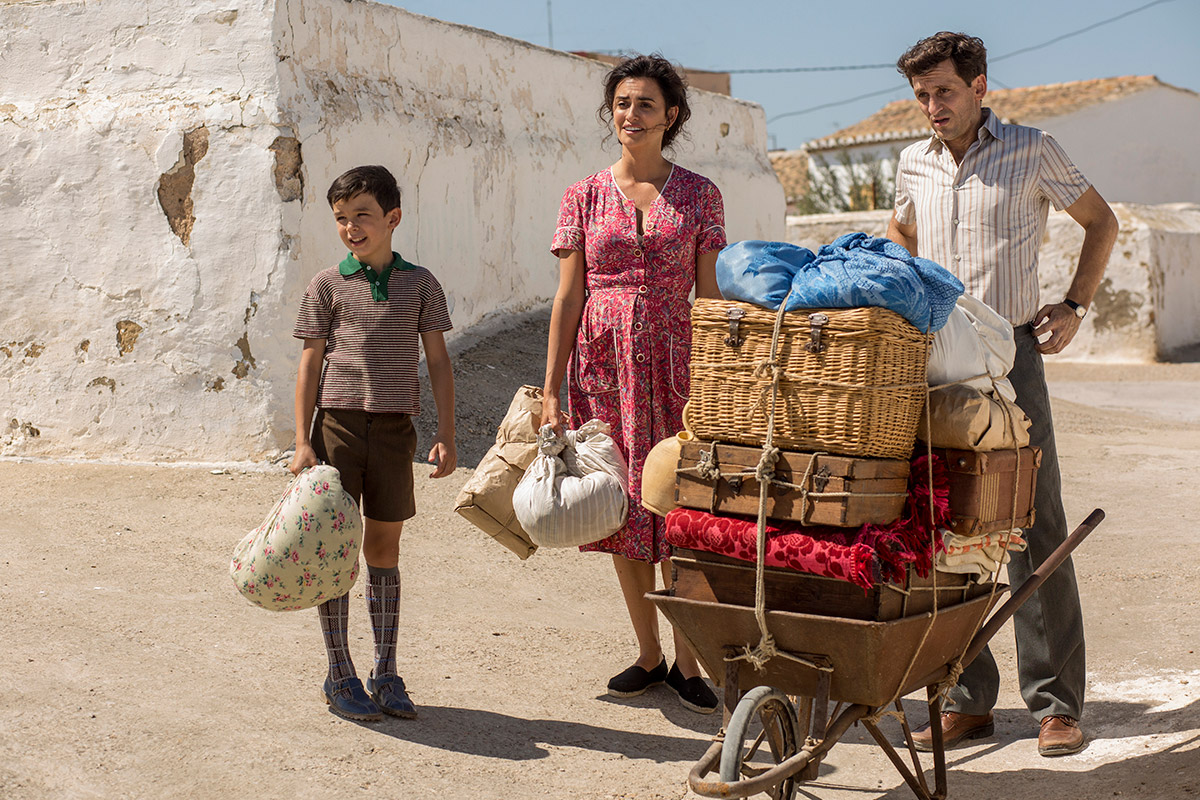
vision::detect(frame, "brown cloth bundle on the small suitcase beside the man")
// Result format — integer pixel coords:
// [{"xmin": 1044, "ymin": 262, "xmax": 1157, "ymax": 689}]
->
[{"xmin": 917, "ymin": 381, "xmax": 1032, "ymax": 450}]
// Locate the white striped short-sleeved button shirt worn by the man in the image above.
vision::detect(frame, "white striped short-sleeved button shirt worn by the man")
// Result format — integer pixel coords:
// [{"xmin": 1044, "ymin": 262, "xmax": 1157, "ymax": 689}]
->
[{"xmin": 895, "ymin": 108, "xmax": 1091, "ymax": 325}]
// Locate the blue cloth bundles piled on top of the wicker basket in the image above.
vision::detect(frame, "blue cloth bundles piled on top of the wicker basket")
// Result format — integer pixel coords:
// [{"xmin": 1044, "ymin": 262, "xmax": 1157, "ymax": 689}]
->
[{"xmin": 716, "ymin": 233, "xmax": 962, "ymax": 333}]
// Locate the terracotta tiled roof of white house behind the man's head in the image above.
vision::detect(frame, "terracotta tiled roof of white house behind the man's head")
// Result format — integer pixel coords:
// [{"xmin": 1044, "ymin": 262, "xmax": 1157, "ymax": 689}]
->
[{"xmin": 806, "ymin": 76, "xmax": 1180, "ymax": 150}]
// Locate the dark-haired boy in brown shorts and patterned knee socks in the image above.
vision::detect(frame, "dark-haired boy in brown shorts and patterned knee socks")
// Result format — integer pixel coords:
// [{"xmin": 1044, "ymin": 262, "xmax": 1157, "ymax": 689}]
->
[{"xmin": 288, "ymin": 167, "xmax": 457, "ymax": 720}]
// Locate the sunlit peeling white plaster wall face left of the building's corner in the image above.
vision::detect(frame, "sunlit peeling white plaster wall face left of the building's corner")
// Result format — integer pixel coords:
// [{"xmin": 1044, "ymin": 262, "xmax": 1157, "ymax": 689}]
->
[{"xmin": 0, "ymin": 0, "xmax": 290, "ymax": 459}]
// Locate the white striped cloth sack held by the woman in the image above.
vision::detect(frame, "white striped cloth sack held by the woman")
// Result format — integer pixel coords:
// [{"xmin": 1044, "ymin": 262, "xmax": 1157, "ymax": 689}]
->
[{"xmin": 512, "ymin": 420, "xmax": 629, "ymax": 547}]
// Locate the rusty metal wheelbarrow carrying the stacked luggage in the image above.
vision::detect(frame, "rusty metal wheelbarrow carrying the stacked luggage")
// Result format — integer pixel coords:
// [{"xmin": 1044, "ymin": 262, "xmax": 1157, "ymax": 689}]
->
[{"xmin": 647, "ymin": 509, "xmax": 1104, "ymax": 800}]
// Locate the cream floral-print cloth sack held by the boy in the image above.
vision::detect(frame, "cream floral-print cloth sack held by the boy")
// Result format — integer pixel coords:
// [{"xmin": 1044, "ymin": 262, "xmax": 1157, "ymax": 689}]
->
[{"xmin": 229, "ymin": 464, "xmax": 362, "ymax": 612}]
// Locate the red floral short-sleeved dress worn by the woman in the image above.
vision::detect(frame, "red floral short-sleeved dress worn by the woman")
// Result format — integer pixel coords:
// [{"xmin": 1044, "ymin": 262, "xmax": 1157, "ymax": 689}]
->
[{"xmin": 551, "ymin": 166, "xmax": 725, "ymax": 564}]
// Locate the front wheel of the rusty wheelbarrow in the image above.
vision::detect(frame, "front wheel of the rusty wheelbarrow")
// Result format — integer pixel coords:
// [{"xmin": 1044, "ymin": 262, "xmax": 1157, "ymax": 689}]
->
[{"xmin": 720, "ymin": 686, "xmax": 797, "ymax": 800}]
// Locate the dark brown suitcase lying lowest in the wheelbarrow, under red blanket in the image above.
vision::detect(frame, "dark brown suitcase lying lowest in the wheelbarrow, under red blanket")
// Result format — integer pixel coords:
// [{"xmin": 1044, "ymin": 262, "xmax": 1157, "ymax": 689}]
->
[{"xmin": 671, "ymin": 547, "xmax": 991, "ymax": 622}]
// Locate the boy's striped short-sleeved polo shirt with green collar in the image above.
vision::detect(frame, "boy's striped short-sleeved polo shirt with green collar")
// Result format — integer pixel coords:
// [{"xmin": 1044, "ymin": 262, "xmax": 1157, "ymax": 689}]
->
[{"xmin": 292, "ymin": 260, "xmax": 452, "ymax": 415}]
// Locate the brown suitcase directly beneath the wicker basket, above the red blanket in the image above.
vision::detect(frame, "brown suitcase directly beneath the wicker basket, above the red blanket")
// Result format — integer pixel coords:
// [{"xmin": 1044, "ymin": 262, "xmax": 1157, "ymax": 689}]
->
[{"xmin": 676, "ymin": 441, "xmax": 910, "ymax": 528}]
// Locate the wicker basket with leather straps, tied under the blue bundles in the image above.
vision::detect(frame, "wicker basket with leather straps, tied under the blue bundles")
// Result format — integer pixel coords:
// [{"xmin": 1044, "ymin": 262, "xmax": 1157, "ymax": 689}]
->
[{"xmin": 685, "ymin": 299, "xmax": 932, "ymax": 458}]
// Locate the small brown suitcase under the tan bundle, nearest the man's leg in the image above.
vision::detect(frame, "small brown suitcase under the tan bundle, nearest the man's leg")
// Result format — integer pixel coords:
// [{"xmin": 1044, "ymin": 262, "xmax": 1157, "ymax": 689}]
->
[{"xmin": 934, "ymin": 447, "xmax": 1042, "ymax": 536}]
